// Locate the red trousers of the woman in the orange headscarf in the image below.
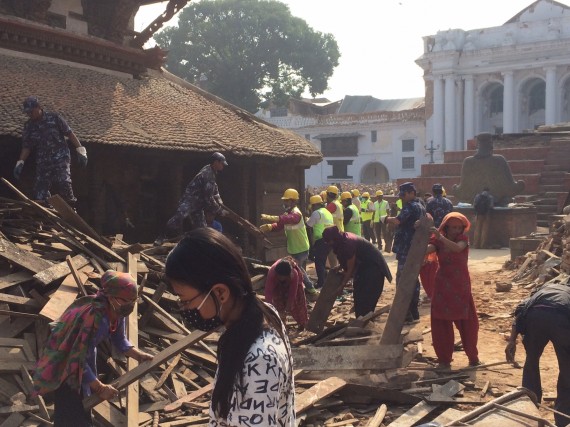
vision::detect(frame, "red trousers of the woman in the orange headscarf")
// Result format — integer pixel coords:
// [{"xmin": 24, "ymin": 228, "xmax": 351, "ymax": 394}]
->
[{"xmin": 431, "ymin": 310, "xmax": 479, "ymax": 363}]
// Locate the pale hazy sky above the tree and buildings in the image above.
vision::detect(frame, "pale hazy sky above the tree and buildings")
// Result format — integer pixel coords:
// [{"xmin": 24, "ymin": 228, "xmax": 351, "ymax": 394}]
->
[{"xmin": 135, "ymin": 0, "xmax": 570, "ymax": 101}]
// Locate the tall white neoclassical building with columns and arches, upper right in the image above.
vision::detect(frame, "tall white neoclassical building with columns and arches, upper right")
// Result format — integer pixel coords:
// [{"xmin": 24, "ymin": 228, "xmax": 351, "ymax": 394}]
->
[{"xmin": 416, "ymin": 0, "xmax": 570, "ymax": 154}]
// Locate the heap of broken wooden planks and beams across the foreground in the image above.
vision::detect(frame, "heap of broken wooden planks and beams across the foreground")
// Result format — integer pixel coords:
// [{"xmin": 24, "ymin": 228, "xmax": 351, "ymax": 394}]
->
[{"xmin": 0, "ymin": 191, "xmax": 552, "ymax": 427}]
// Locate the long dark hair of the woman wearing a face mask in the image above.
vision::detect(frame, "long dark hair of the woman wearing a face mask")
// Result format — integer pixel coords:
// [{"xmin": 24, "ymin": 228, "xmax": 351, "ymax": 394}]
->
[{"xmin": 165, "ymin": 227, "xmax": 285, "ymax": 418}]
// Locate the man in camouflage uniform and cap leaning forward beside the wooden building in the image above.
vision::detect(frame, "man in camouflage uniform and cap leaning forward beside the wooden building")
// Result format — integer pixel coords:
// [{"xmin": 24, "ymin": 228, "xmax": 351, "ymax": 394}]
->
[{"xmin": 154, "ymin": 152, "xmax": 228, "ymax": 246}]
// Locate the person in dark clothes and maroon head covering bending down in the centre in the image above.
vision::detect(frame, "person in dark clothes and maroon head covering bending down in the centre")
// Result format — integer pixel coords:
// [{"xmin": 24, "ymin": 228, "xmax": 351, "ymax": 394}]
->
[{"xmin": 323, "ymin": 226, "xmax": 392, "ymax": 317}]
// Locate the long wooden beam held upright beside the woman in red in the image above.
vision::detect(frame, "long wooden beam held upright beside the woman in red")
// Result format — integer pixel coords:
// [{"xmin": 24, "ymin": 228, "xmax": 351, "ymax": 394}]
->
[{"xmin": 380, "ymin": 217, "xmax": 433, "ymax": 344}]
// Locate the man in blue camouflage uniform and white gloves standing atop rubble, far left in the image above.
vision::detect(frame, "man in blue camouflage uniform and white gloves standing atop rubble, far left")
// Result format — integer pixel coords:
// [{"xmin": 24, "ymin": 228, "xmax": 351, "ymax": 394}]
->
[{"xmin": 14, "ymin": 96, "xmax": 87, "ymax": 207}]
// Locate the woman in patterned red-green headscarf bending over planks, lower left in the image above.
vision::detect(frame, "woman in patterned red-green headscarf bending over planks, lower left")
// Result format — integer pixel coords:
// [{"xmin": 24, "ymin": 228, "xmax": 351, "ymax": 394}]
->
[{"xmin": 33, "ymin": 270, "xmax": 153, "ymax": 427}]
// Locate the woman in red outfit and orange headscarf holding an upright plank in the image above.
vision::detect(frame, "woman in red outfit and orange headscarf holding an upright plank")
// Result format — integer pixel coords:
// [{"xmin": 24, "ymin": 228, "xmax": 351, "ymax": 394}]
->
[{"xmin": 427, "ymin": 212, "xmax": 481, "ymax": 369}]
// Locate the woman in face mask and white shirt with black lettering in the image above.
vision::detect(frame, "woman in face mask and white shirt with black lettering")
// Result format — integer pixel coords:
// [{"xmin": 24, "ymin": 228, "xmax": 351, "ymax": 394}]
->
[{"xmin": 165, "ymin": 228, "xmax": 295, "ymax": 427}]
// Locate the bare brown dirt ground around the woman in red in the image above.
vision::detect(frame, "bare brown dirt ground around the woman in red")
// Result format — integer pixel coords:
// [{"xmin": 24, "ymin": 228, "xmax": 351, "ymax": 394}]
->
[{"xmin": 309, "ymin": 248, "xmax": 558, "ymax": 422}]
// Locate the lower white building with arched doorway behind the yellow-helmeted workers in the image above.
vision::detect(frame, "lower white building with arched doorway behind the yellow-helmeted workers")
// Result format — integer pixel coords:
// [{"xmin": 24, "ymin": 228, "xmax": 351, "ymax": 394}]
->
[{"xmin": 256, "ymin": 96, "xmax": 424, "ymax": 187}]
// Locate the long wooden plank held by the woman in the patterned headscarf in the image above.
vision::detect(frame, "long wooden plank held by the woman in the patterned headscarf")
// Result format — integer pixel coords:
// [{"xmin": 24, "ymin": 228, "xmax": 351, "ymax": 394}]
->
[{"xmin": 85, "ymin": 331, "xmax": 214, "ymax": 409}]
